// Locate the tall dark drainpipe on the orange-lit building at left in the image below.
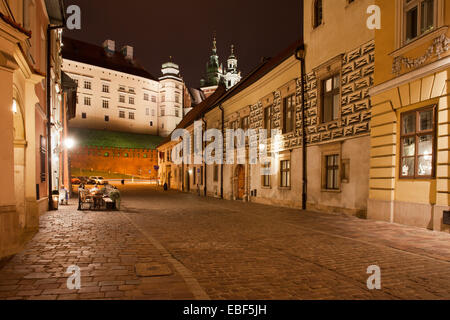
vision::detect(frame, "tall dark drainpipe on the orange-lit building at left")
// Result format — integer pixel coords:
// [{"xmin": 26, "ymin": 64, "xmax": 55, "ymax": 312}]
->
[{"xmin": 46, "ymin": 25, "xmax": 64, "ymax": 210}]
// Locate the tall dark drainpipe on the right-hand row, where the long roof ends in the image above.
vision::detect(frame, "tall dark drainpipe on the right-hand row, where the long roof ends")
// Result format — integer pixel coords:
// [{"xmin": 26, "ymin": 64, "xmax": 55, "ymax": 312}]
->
[{"xmin": 295, "ymin": 45, "xmax": 308, "ymax": 210}]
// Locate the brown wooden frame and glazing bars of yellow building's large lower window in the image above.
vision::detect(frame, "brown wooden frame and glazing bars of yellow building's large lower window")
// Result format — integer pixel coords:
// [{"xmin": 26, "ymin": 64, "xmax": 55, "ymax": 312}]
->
[{"xmin": 398, "ymin": 104, "xmax": 437, "ymax": 180}]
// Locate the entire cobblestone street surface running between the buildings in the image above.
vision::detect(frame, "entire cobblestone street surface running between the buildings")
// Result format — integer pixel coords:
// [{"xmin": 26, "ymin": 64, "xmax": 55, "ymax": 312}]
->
[{"xmin": 0, "ymin": 186, "xmax": 450, "ymax": 299}]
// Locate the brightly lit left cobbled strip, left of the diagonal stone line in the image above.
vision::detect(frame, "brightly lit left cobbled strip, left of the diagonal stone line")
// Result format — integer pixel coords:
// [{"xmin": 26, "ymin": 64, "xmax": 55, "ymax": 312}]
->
[{"xmin": 0, "ymin": 201, "xmax": 194, "ymax": 300}]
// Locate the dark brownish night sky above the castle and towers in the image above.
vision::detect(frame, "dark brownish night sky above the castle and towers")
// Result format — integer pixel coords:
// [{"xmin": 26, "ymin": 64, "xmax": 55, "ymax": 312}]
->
[{"xmin": 65, "ymin": 0, "xmax": 302, "ymax": 87}]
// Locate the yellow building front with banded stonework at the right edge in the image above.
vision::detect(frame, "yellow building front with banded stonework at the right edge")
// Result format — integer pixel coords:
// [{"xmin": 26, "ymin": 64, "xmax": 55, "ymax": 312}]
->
[{"xmin": 368, "ymin": 0, "xmax": 450, "ymax": 232}]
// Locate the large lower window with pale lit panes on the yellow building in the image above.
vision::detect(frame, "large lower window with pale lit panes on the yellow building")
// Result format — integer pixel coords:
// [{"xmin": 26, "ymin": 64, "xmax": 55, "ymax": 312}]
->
[{"xmin": 400, "ymin": 106, "xmax": 436, "ymax": 178}]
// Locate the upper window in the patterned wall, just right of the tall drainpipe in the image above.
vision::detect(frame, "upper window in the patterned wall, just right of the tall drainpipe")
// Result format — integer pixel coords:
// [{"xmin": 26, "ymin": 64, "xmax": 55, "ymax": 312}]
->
[{"xmin": 321, "ymin": 75, "xmax": 341, "ymax": 123}]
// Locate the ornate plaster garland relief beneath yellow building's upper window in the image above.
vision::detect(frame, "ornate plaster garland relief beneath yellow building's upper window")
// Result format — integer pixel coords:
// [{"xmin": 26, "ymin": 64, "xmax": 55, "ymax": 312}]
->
[{"xmin": 392, "ymin": 34, "xmax": 450, "ymax": 75}]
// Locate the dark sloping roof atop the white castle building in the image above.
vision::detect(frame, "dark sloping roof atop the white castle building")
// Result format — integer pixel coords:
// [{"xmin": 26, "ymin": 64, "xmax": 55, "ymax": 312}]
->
[{"xmin": 62, "ymin": 37, "xmax": 156, "ymax": 80}]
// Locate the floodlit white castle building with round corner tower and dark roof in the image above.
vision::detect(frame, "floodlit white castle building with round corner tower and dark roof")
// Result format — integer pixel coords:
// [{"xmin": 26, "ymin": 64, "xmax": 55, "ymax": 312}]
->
[{"xmin": 63, "ymin": 38, "xmax": 185, "ymax": 136}]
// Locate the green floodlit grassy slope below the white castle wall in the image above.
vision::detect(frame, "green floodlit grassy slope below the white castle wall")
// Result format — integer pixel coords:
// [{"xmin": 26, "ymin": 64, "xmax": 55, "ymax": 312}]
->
[{"xmin": 69, "ymin": 127, "xmax": 163, "ymax": 149}]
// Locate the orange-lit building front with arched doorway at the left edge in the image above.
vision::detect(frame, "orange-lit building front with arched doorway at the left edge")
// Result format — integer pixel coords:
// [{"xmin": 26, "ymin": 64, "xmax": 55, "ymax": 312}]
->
[{"xmin": 0, "ymin": 0, "xmax": 64, "ymax": 259}]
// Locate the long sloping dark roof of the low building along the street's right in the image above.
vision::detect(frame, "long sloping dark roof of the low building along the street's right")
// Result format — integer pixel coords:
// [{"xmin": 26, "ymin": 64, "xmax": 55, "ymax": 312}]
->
[{"xmin": 158, "ymin": 40, "xmax": 303, "ymax": 147}]
